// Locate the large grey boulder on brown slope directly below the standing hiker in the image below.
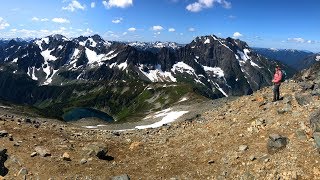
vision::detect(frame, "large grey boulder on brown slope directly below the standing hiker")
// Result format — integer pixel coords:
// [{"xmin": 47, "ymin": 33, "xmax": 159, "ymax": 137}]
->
[{"xmin": 267, "ymin": 134, "xmax": 288, "ymax": 154}]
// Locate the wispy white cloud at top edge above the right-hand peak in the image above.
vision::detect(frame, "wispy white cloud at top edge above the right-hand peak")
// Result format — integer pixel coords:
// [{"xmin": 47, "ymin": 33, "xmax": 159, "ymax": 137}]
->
[{"xmin": 186, "ymin": 0, "xmax": 231, "ymax": 12}]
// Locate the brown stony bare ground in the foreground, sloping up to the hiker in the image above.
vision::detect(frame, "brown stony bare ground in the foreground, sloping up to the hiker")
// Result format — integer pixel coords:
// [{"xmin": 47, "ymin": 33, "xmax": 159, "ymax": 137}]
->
[{"xmin": 0, "ymin": 82, "xmax": 320, "ymax": 180}]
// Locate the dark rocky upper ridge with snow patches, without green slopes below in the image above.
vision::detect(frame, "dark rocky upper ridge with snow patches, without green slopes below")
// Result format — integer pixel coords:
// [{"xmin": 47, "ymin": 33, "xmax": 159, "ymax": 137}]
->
[{"xmin": 1, "ymin": 35, "xmax": 288, "ymax": 96}]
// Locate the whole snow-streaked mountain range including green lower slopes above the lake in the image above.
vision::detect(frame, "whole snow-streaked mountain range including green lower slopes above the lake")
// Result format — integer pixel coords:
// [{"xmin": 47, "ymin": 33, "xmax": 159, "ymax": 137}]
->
[{"xmin": 0, "ymin": 34, "xmax": 293, "ymax": 121}]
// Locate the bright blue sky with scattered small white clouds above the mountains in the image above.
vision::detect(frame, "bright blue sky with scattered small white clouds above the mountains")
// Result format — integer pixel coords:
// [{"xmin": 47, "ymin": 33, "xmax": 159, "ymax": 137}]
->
[{"xmin": 0, "ymin": 0, "xmax": 320, "ymax": 52}]
